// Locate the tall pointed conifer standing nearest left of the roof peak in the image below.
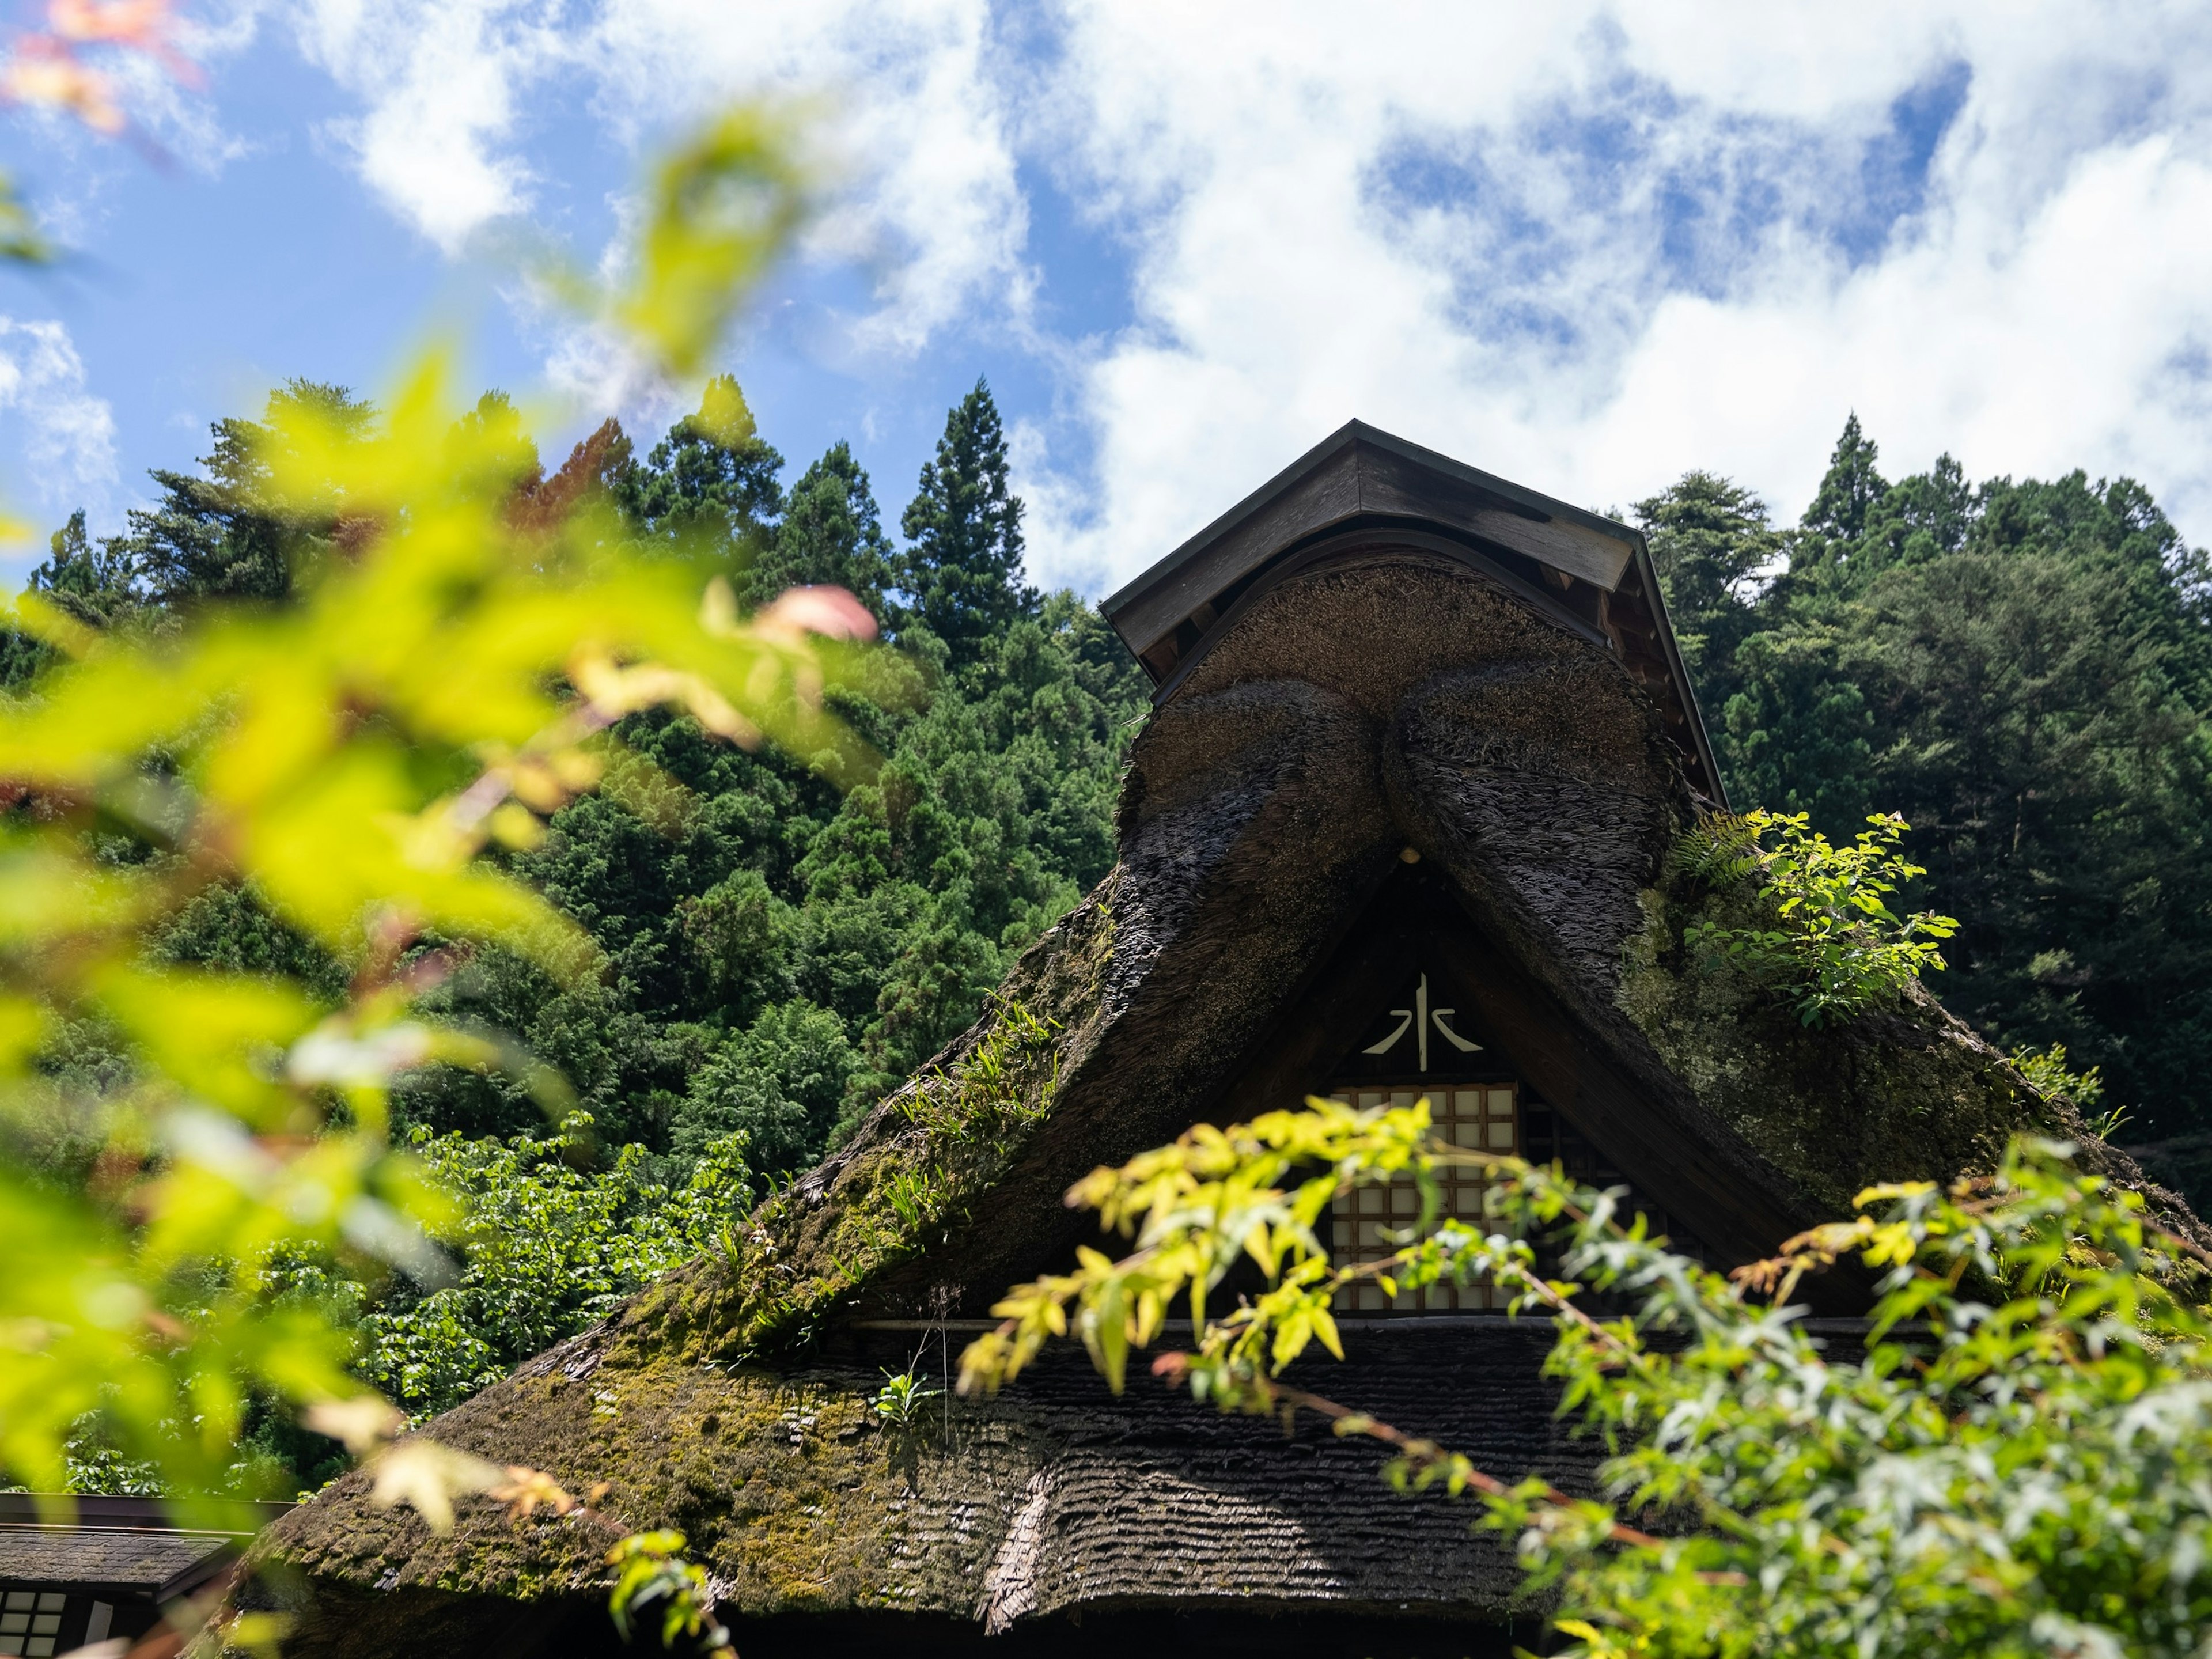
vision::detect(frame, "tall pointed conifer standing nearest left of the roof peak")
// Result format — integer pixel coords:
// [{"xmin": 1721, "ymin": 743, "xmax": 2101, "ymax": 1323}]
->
[{"xmin": 896, "ymin": 378, "xmax": 1037, "ymax": 664}]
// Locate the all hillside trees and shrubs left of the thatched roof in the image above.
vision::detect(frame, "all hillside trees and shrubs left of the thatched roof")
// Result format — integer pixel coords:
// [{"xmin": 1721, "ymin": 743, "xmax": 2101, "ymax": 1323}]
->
[{"xmin": 13, "ymin": 378, "xmax": 1148, "ymax": 1491}]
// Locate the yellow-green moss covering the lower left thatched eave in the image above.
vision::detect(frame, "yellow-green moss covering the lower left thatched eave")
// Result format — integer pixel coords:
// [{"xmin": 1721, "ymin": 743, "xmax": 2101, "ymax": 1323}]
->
[{"xmin": 249, "ymin": 1332, "xmax": 1044, "ymax": 1652}]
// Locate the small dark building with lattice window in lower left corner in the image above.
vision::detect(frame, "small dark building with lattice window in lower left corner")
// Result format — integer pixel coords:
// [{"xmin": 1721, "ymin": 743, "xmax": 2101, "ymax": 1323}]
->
[{"xmin": 0, "ymin": 1493, "xmax": 290, "ymax": 1654}]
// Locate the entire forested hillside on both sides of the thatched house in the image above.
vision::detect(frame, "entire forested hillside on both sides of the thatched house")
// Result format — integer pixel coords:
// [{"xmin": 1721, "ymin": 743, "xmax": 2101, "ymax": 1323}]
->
[{"xmin": 17, "ymin": 378, "xmax": 2212, "ymax": 1488}]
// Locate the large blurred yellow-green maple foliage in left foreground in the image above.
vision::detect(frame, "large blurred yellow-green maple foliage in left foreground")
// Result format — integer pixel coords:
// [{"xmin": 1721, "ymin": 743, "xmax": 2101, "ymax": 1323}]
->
[{"xmin": 0, "ymin": 345, "xmax": 862, "ymax": 1491}]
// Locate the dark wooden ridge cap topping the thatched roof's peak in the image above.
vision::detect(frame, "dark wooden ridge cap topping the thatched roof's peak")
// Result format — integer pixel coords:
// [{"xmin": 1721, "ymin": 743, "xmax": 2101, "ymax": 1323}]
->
[{"xmin": 1101, "ymin": 421, "xmax": 1725, "ymax": 801}]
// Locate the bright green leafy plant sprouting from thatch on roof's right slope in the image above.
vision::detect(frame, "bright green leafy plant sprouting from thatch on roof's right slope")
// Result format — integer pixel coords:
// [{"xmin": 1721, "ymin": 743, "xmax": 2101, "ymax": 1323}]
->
[{"xmin": 1677, "ymin": 812, "xmax": 1957, "ymax": 1027}]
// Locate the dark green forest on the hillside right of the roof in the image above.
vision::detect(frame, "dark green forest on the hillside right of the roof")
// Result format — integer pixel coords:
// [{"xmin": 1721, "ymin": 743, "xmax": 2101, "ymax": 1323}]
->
[{"xmin": 1639, "ymin": 421, "xmax": 2212, "ymax": 1137}]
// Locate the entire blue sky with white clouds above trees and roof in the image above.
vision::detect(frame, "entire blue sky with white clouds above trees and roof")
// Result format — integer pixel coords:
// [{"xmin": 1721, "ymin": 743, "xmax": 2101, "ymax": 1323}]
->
[{"xmin": 0, "ymin": 0, "xmax": 2212, "ymax": 593}]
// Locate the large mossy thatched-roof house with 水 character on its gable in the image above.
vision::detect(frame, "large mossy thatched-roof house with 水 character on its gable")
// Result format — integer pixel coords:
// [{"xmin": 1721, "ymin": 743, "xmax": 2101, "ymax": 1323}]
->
[{"xmin": 254, "ymin": 422, "xmax": 2194, "ymax": 1659}]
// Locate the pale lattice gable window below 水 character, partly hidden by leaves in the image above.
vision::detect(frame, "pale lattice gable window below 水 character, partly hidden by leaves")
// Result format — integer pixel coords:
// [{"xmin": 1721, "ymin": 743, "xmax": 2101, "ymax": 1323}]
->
[{"xmin": 1330, "ymin": 1084, "xmax": 1520, "ymax": 1314}]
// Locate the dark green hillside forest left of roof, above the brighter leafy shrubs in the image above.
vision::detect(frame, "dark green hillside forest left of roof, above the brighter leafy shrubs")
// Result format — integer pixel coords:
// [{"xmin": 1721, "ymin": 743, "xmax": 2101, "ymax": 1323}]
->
[{"xmin": 17, "ymin": 378, "xmax": 1146, "ymax": 1175}]
